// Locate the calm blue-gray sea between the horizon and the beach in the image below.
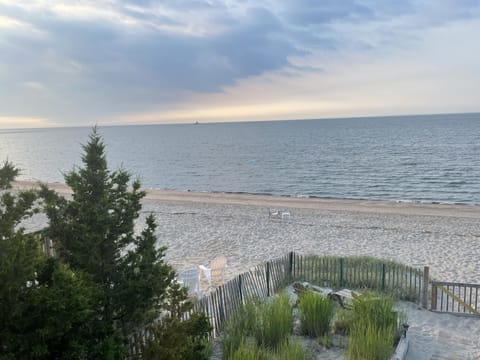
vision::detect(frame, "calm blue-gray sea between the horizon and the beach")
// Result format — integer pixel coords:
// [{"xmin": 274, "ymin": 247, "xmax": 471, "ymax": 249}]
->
[{"xmin": 0, "ymin": 114, "xmax": 480, "ymax": 204}]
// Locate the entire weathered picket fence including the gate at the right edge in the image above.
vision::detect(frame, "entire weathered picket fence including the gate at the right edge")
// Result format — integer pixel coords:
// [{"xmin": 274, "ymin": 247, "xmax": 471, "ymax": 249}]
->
[{"xmin": 31, "ymin": 231, "xmax": 480, "ymax": 352}]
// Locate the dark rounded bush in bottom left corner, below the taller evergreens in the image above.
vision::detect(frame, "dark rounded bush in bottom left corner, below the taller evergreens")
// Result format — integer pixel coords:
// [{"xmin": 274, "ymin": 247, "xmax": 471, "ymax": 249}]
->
[{"xmin": 0, "ymin": 259, "xmax": 96, "ymax": 359}]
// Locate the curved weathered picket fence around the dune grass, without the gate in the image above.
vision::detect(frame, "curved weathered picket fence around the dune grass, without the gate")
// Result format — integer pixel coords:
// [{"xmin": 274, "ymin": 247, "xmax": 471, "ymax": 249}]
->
[{"xmin": 125, "ymin": 252, "xmax": 428, "ymax": 358}]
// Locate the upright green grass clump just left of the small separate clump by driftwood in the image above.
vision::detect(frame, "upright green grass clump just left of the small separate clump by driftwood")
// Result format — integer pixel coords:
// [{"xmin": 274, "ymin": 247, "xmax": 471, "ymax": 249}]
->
[{"xmin": 254, "ymin": 293, "xmax": 293, "ymax": 349}]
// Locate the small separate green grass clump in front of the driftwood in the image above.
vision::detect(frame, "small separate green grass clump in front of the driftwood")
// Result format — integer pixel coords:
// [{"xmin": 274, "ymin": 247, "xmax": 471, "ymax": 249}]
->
[{"xmin": 299, "ymin": 291, "xmax": 334, "ymax": 337}]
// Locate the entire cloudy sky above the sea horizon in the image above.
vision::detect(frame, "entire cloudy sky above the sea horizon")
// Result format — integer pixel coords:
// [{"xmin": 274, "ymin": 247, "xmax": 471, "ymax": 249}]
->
[{"xmin": 0, "ymin": 0, "xmax": 480, "ymax": 128}]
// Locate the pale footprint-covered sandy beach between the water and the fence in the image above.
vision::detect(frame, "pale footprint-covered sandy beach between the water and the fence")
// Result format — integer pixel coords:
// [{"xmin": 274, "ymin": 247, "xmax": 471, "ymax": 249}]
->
[{"xmin": 15, "ymin": 182, "xmax": 480, "ymax": 360}]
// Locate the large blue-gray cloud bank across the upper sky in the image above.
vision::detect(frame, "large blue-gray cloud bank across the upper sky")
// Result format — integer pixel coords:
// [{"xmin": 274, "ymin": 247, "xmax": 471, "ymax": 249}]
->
[{"xmin": 0, "ymin": 0, "xmax": 478, "ymax": 123}]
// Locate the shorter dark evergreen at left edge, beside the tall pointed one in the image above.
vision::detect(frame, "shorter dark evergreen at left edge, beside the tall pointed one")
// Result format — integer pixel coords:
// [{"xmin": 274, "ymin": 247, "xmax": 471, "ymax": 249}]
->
[{"xmin": 0, "ymin": 167, "xmax": 95, "ymax": 360}]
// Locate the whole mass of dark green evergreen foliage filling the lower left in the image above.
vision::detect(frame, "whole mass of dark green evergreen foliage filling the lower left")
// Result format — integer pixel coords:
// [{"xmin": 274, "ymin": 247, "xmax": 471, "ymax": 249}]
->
[{"xmin": 0, "ymin": 129, "xmax": 210, "ymax": 360}]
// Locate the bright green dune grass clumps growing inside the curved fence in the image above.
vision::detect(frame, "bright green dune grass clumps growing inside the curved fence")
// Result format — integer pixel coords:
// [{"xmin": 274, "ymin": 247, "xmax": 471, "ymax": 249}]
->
[{"xmin": 222, "ymin": 291, "xmax": 406, "ymax": 360}]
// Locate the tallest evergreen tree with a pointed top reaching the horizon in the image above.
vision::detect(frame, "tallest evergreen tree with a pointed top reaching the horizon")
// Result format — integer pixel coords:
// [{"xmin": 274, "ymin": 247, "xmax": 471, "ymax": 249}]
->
[{"xmin": 42, "ymin": 128, "xmax": 175, "ymax": 356}]
